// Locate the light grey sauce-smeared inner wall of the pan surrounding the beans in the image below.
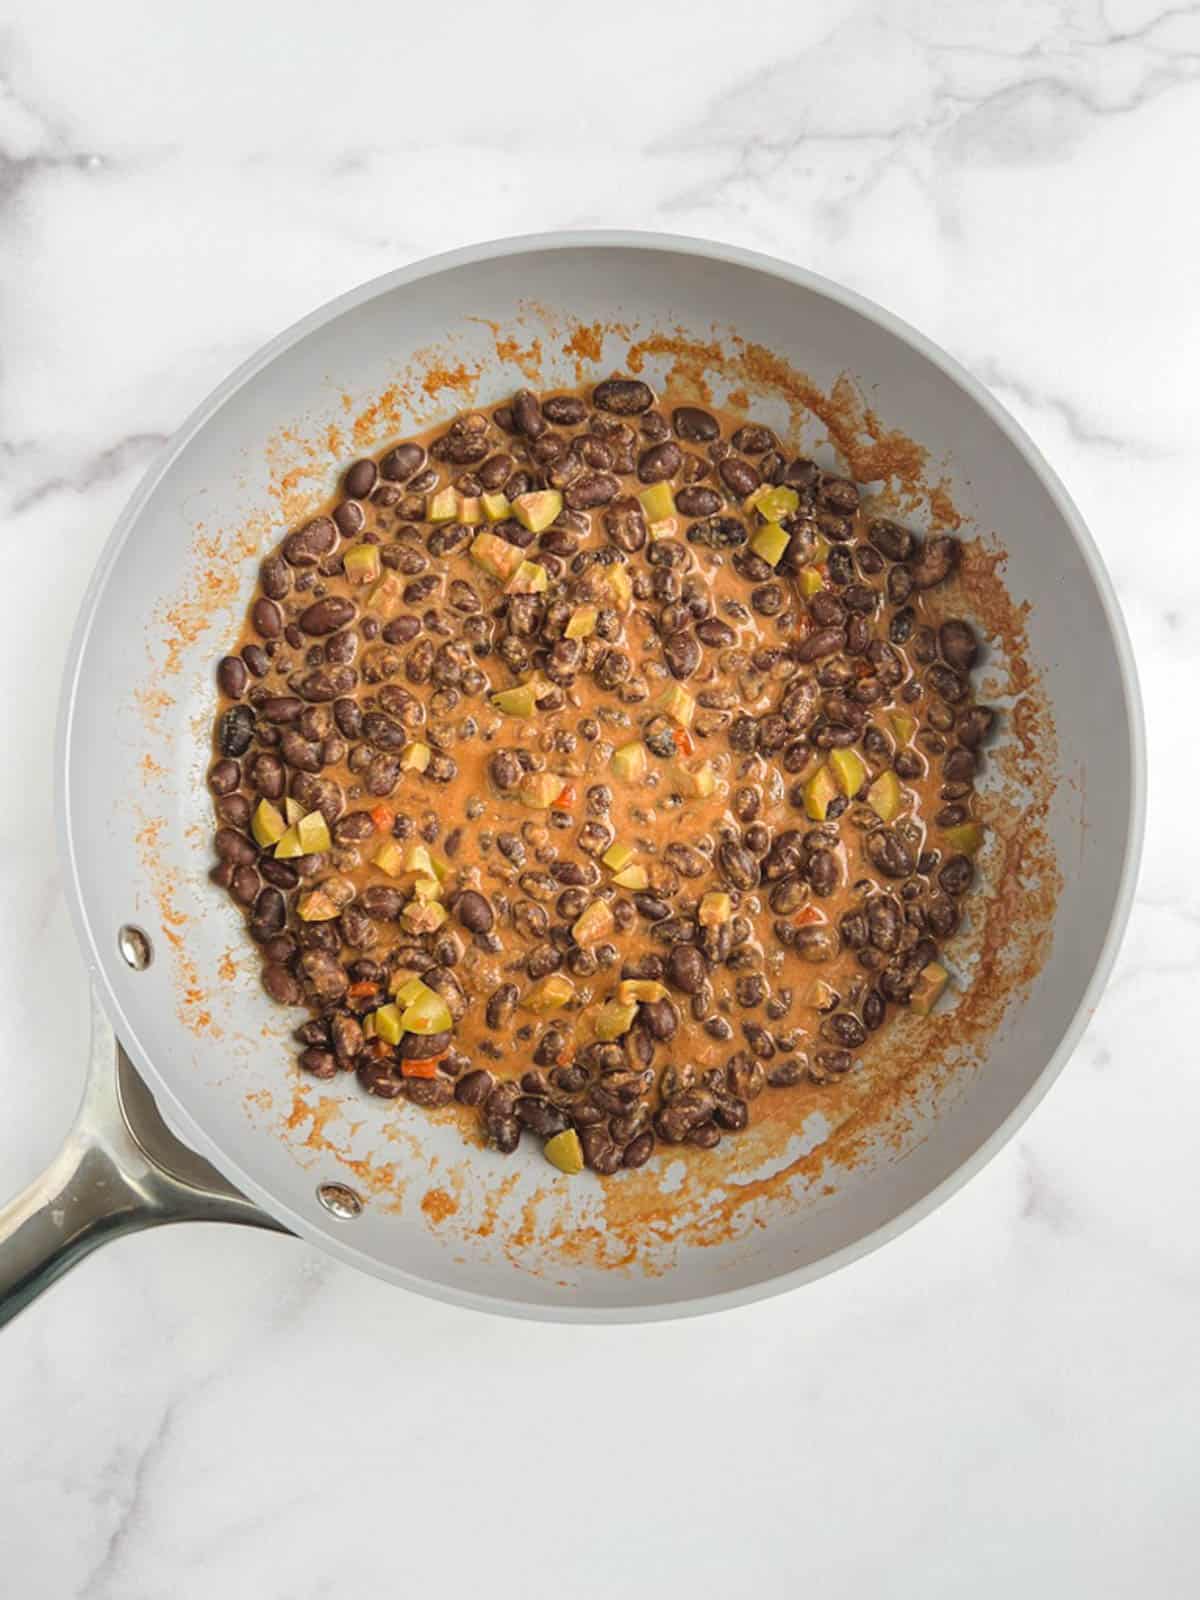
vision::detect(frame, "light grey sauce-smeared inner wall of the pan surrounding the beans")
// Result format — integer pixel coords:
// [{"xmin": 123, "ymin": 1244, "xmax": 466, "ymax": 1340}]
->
[{"xmin": 62, "ymin": 237, "xmax": 1138, "ymax": 1317}]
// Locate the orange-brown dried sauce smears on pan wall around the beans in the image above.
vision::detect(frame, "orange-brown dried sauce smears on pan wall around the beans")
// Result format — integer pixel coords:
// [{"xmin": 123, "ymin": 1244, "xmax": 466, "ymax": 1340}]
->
[{"xmin": 139, "ymin": 306, "xmax": 1059, "ymax": 1277}]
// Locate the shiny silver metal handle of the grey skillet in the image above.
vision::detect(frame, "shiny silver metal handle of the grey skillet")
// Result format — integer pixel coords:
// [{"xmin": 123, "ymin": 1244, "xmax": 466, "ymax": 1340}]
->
[{"xmin": 0, "ymin": 998, "xmax": 286, "ymax": 1326}]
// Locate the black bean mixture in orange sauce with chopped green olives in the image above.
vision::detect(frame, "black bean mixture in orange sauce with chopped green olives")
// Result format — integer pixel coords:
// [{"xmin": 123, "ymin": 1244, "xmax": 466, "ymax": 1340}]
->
[{"xmin": 208, "ymin": 378, "xmax": 994, "ymax": 1174}]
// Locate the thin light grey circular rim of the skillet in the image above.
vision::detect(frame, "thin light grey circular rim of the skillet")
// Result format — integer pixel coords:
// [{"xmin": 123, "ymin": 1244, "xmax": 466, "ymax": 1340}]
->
[{"xmin": 53, "ymin": 229, "xmax": 1147, "ymax": 1323}]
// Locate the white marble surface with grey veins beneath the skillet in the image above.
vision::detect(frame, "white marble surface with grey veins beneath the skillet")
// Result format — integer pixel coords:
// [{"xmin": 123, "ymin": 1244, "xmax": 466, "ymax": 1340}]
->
[{"xmin": 0, "ymin": 0, "xmax": 1200, "ymax": 1600}]
